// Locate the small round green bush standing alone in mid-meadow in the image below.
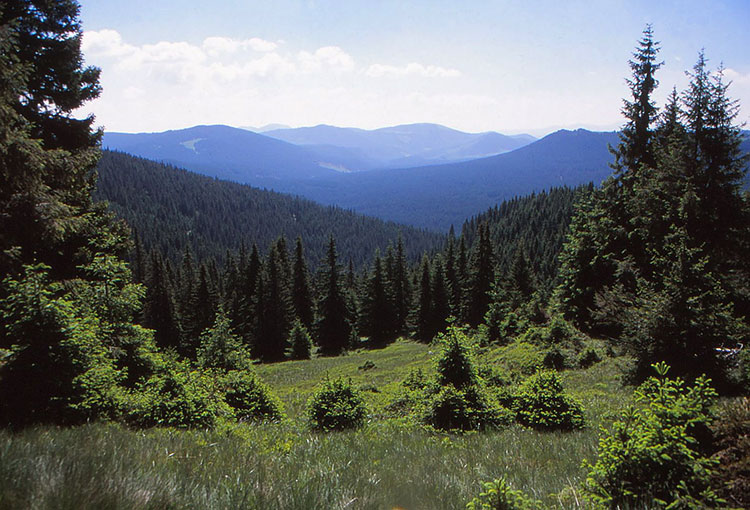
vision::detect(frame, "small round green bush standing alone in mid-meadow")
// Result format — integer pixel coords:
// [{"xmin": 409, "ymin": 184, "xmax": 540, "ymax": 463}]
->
[{"xmin": 307, "ymin": 378, "xmax": 367, "ymax": 431}]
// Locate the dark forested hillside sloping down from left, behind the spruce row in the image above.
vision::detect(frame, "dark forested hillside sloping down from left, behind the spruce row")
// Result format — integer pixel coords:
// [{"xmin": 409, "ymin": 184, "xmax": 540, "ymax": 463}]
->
[{"xmin": 96, "ymin": 151, "xmax": 443, "ymax": 267}]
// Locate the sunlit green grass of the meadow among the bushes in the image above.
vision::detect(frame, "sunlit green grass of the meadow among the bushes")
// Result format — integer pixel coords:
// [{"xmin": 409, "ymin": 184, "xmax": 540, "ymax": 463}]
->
[{"xmin": 0, "ymin": 341, "xmax": 629, "ymax": 510}]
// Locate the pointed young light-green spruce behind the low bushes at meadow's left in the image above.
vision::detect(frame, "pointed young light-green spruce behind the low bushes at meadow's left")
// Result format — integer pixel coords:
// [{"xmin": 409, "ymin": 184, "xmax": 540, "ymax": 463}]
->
[{"xmin": 197, "ymin": 309, "xmax": 250, "ymax": 370}]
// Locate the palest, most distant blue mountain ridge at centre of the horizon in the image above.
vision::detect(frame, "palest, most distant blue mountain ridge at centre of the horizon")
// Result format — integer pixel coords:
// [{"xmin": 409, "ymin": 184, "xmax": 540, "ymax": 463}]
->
[{"xmin": 264, "ymin": 124, "xmax": 535, "ymax": 171}]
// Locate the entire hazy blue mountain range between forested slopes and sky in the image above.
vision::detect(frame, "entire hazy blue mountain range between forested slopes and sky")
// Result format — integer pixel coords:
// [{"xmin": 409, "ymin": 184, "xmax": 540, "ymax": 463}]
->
[{"xmin": 103, "ymin": 124, "xmax": 750, "ymax": 231}]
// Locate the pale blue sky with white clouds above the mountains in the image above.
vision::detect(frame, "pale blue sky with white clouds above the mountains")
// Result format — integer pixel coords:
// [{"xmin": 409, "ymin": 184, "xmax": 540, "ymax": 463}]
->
[{"xmin": 80, "ymin": 0, "xmax": 750, "ymax": 136}]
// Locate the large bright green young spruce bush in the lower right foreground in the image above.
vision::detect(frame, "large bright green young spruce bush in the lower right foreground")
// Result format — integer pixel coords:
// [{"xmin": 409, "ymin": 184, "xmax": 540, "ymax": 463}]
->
[{"xmin": 584, "ymin": 363, "xmax": 719, "ymax": 508}]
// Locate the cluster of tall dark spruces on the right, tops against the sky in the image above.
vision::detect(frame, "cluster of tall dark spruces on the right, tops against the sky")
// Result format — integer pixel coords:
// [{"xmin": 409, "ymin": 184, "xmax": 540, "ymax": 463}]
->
[{"xmin": 555, "ymin": 27, "xmax": 750, "ymax": 389}]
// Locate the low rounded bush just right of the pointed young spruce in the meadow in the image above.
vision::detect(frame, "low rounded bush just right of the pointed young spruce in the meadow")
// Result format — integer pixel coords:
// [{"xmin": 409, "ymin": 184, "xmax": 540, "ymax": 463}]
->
[{"xmin": 513, "ymin": 371, "xmax": 584, "ymax": 430}]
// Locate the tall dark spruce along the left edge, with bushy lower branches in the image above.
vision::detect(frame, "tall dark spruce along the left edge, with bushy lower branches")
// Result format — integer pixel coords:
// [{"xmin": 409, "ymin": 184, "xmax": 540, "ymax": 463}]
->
[{"xmin": 0, "ymin": 0, "xmax": 162, "ymax": 426}]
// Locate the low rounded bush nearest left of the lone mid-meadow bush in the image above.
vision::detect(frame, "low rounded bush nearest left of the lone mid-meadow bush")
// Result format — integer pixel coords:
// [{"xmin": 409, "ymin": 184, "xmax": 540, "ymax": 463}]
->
[{"xmin": 222, "ymin": 370, "xmax": 282, "ymax": 420}]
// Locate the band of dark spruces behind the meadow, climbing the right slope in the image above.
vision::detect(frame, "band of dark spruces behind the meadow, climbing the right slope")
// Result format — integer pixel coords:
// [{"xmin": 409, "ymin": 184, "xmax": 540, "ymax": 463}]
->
[{"xmin": 132, "ymin": 184, "xmax": 588, "ymax": 361}]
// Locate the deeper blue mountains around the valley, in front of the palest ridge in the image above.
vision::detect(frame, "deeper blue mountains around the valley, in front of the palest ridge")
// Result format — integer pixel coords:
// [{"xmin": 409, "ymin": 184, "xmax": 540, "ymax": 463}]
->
[{"xmin": 104, "ymin": 126, "xmax": 618, "ymax": 230}]
